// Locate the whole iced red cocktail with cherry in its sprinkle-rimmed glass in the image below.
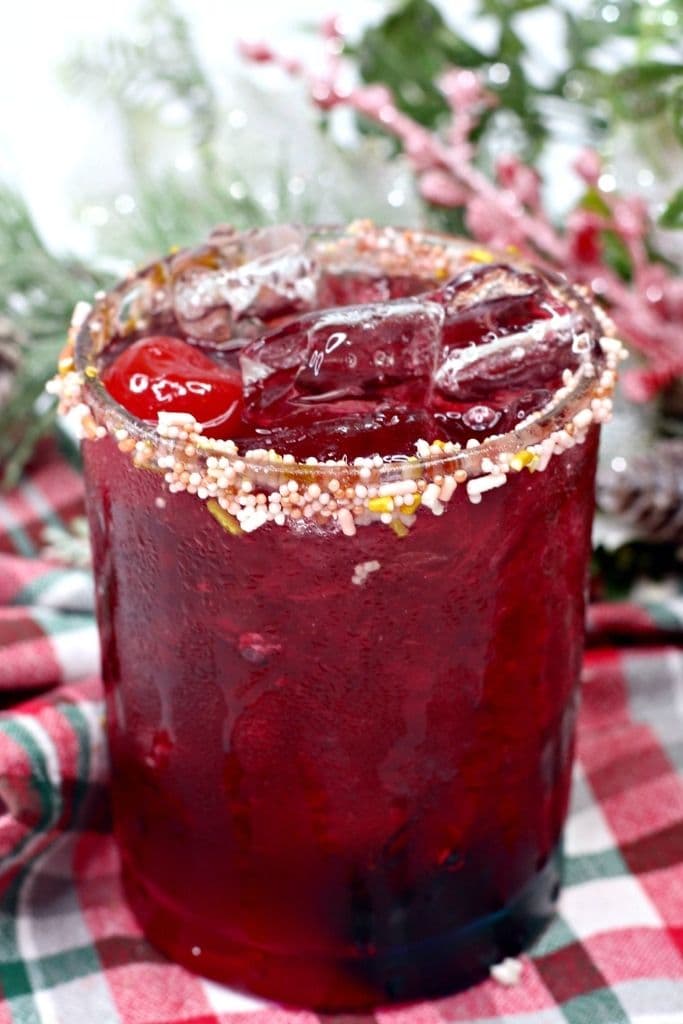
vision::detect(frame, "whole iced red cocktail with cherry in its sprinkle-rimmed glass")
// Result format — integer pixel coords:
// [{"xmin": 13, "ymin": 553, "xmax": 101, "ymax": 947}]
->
[{"xmin": 60, "ymin": 227, "xmax": 617, "ymax": 1010}]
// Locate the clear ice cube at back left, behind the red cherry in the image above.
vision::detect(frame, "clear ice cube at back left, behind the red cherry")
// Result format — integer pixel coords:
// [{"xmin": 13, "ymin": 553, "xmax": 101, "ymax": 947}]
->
[{"xmin": 173, "ymin": 226, "xmax": 318, "ymax": 345}]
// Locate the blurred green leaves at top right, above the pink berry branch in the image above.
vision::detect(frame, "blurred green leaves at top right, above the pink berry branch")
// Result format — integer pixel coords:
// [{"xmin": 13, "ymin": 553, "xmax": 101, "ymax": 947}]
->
[{"xmin": 351, "ymin": 0, "xmax": 683, "ymax": 182}]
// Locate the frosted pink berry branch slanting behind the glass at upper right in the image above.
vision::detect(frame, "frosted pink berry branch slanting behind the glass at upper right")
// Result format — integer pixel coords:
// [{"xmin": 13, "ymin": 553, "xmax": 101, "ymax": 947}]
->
[{"xmin": 241, "ymin": 18, "xmax": 683, "ymax": 401}]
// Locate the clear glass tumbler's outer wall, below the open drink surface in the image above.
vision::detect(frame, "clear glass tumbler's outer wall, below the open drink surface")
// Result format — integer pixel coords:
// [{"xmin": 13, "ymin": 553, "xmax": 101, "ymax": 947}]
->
[{"xmin": 62, "ymin": 226, "xmax": 618, "ymax": 1010}]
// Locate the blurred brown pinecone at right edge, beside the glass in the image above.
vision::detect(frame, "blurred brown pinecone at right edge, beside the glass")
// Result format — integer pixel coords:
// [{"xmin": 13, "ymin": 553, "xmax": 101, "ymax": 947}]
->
[{"xmin": 597, "ymin": 438, "xmax": 683, "ymax": 544}]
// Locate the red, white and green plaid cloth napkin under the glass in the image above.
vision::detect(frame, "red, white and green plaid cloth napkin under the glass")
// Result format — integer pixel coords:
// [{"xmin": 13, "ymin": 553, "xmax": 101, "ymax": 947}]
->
[{"xmin": 0, "ymin": 455, "xmax": 683, "ymax": 1024}]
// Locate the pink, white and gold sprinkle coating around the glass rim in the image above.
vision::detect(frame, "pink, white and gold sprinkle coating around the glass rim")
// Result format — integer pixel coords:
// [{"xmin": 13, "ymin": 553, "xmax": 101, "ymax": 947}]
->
[{"xmin": 56, "ymin": 221, "xmax": 626, "ymax": 536}]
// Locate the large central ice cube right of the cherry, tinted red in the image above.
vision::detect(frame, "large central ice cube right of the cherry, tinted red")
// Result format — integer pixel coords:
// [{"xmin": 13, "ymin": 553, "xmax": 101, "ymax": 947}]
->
[{"xmin": 240, "ymin": 299, "xmax": 443, "ymax": 427}]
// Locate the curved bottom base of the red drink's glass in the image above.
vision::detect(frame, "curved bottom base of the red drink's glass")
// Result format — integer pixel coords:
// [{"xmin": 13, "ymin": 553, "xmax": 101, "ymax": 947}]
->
[{"xmin": 124, "ymin": 850, "xmax": 561, "ymax": 1011}]
